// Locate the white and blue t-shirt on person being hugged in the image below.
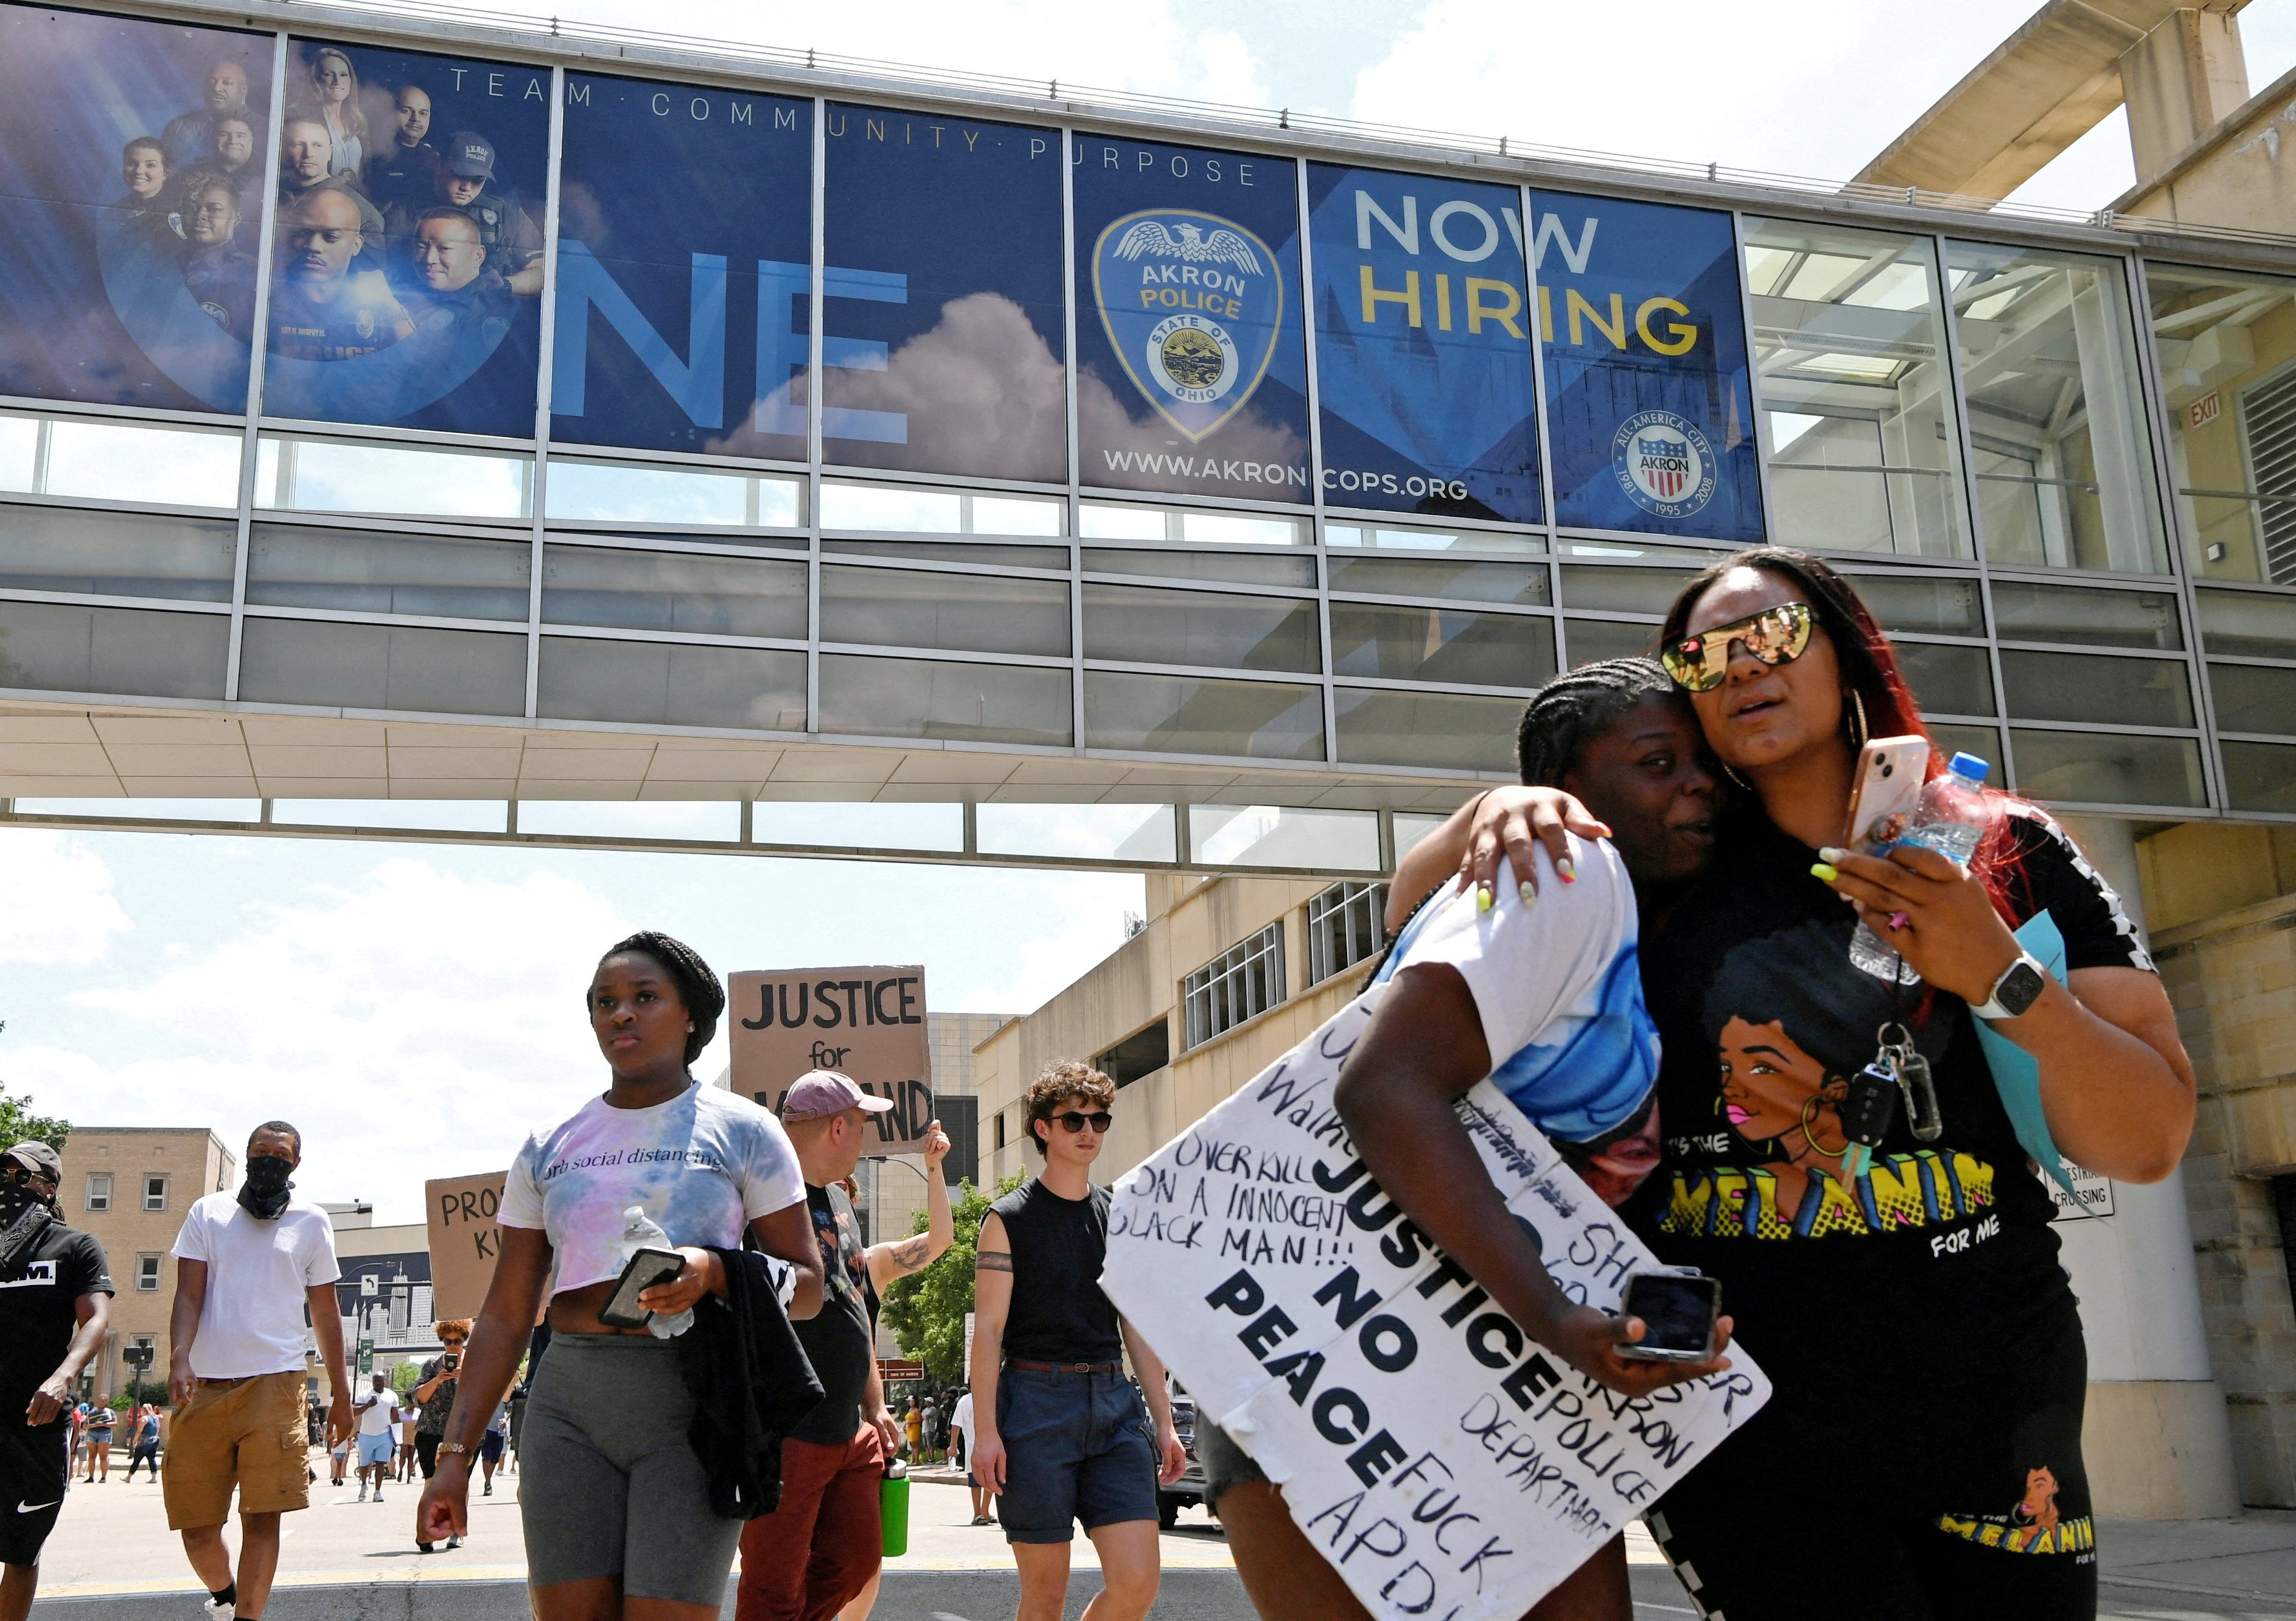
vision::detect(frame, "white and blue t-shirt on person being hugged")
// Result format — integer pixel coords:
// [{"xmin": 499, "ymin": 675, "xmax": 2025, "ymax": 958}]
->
[{"xmin": 1378, "ymin": 836, "xmax": 1658, "ymax": 1143}]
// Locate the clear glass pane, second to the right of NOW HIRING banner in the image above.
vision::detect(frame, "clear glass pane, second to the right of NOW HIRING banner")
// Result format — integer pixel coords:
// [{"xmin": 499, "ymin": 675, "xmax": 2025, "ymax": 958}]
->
[{"xmin": 1947, "ymin": 241, "xmax": 2168, "ymax": 574}]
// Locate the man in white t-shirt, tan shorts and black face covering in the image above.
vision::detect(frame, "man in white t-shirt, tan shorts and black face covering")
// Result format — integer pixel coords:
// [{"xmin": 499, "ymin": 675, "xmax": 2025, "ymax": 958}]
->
[{"xmin": 161, "ymin": 1121, "xmax": 356, "ymax": 1621}]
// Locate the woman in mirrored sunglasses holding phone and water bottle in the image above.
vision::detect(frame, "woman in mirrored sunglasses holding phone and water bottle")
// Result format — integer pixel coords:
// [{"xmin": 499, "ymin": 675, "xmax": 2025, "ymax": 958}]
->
[{"xmin": 1398, "ymin": 547, "xmax": 2193, "ymax": 1621}]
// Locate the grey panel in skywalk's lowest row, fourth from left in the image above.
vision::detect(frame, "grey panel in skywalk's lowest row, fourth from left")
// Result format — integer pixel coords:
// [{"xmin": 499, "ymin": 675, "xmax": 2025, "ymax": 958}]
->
[{"xmin": 820, "ymin": 652, "xmax": 1075, "ymax": 746}]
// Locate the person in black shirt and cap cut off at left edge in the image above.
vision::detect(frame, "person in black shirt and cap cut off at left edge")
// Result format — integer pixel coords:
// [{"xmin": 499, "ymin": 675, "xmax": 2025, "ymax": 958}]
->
[{"xmin": 0, "ymin": 1141, "xmax": 113, "ymax": 1621}]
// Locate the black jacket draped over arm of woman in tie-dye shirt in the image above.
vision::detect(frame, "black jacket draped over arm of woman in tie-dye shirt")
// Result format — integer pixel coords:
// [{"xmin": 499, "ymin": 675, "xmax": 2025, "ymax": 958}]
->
[{"xmin": 680, "ymin": 1249, "xmax": 822, "ymax": 1520}]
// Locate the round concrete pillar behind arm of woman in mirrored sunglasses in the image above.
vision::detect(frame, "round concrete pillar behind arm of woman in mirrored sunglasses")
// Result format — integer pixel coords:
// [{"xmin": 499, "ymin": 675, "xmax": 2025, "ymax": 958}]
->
[{"xmin": 2057, "ymin": 815, "xmax": 2241, "ymax": 1520}]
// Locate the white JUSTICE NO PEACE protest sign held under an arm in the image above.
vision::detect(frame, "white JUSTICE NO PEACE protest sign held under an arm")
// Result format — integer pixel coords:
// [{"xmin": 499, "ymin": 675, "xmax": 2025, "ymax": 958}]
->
[{"xmin": 1102, "ymin": 992, "xmax": 1770, "ymax": 1621}]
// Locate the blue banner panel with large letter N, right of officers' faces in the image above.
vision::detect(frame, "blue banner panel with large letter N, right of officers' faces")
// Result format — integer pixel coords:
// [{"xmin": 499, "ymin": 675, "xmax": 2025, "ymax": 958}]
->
[{"xmin": 551, "ymin": 74, "xmax": 813, "ymax": 461}]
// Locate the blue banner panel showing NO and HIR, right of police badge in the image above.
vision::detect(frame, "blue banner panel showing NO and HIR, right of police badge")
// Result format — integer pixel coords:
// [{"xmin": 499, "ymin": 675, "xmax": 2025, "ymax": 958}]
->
[{"xmin": 1307, "ymin": 163, "xmax": 1543, "ymax": 523}]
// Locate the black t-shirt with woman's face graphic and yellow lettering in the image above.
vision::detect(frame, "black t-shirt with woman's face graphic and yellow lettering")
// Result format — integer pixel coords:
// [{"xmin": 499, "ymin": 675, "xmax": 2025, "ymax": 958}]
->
[{"xmin": 1633, "ymin": 806, "xmax": 2151, "ymax": 1389}]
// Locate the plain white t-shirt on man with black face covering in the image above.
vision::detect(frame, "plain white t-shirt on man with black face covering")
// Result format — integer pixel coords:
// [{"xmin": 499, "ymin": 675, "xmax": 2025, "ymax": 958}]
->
[{"xmin": 175, "ymin": 1189, "xmax": 342, "ymax": 1380}]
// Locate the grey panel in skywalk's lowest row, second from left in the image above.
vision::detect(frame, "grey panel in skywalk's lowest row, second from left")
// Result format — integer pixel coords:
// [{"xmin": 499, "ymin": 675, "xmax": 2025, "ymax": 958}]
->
[{"xmin": 239, "ymin": 618, "xmax": 526, "ymax": 716}]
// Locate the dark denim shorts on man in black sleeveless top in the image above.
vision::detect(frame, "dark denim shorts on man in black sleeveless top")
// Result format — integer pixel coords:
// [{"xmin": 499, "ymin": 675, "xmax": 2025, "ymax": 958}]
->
[{"xmin": 996, "ymin": 1368, "xmax": 1157, "ymax": 1543}]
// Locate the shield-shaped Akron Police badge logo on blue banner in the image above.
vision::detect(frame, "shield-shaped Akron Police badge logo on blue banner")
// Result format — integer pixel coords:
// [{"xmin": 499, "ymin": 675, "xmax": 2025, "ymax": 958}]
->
[{"xmin": 1093, "ymin": 209, "xmax": 1283, "ymax": 441}]
